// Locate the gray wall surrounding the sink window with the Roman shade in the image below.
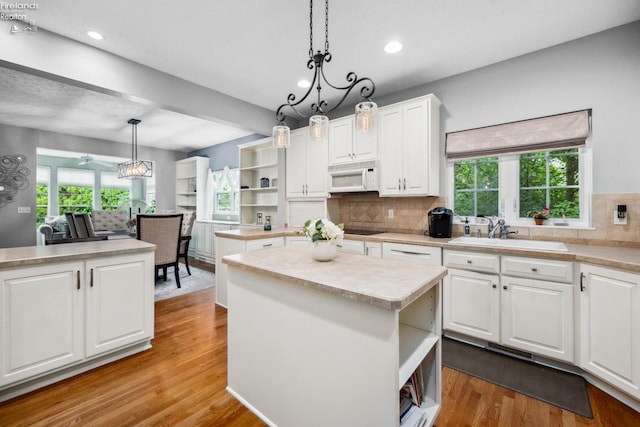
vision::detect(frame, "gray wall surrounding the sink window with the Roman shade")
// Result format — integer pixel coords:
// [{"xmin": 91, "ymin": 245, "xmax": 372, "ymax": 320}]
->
[{"xmin": 336, "ymin": 21, "xmax": 640, "ymax": 194}]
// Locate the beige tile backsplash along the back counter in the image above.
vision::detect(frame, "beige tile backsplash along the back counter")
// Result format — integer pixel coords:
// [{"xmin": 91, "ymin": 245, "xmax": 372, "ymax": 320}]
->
[{"xmin": 331, "ymin": 193, "xmax": 640, "ymax": 247}]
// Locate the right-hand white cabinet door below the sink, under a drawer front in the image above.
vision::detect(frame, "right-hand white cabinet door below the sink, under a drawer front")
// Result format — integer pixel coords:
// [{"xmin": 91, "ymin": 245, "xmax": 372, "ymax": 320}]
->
[{"xmin": 500, "ymin": 276, "xmax": 574, "ymax": 363}]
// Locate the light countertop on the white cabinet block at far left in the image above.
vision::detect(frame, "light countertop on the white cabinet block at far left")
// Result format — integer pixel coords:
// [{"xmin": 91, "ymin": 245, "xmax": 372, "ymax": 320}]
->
[{"xmin": 0, "ymin": 239, "xmax": 156, "ymax": 269}]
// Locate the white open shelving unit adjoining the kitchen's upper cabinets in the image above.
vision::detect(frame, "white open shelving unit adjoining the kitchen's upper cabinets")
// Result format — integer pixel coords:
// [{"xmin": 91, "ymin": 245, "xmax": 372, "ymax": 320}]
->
[{"xmin": 239, "ymin": 138, "xmax": 281, "ymax": 226}]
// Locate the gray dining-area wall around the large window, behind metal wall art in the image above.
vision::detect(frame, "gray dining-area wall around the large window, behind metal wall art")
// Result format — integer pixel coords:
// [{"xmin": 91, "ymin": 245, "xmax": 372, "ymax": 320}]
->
[{"xmin": 0, "ymin": 125, "xmax": 185, "ymax": 248}]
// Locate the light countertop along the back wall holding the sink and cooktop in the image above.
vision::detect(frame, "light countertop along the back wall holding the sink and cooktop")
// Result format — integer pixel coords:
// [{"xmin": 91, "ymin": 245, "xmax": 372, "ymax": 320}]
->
[{"xmin": 216, "ymin": 227, "xmax": 640, "ymax": 273}]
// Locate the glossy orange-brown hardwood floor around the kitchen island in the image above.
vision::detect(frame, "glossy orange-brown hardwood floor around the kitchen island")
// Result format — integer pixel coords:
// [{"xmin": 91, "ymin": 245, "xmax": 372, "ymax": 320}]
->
[{"xmin": 0, "ymin": 289, "xmax": 640, "ymax": 427}]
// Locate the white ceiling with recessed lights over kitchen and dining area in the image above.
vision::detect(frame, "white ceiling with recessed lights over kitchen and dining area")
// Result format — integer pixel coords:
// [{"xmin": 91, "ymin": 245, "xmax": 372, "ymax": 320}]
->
[{"xmin": 0, "ymin": 0, "xmax": 640, "ymax": 151}]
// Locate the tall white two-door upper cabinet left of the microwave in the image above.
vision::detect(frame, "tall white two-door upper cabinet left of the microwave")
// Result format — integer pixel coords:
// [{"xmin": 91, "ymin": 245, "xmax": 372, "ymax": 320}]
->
[{"xmin": 286, "ymin": 128, "xmax": 329, "ymax": 198}]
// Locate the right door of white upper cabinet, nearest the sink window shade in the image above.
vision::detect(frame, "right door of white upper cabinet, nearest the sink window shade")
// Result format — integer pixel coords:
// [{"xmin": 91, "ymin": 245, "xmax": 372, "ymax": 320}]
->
[{"xmin": 402, "ymin": 99, "xmax": 432, "ymax": 195}]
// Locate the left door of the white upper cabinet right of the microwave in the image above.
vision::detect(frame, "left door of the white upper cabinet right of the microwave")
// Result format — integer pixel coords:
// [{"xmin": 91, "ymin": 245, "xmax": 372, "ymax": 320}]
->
[{"xmin": 378, "ymin": 105, "xmax": 402, "ymax": 196}]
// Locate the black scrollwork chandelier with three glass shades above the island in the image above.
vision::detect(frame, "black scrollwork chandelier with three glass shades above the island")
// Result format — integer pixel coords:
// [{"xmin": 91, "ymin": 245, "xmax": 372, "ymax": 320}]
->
[{"xmin": 273, "ymin": 0, "xmax": 378, "ymax": 148}]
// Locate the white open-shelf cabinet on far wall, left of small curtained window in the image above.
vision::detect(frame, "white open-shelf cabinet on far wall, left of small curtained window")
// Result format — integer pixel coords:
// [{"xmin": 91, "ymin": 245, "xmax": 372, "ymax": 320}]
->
[{"xmin": 176, "ymin": 157, "xmax": 209, "ymax": 219}]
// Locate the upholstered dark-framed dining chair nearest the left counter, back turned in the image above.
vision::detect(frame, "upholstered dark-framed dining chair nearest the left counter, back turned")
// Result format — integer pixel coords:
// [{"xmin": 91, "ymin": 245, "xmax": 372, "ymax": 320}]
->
[{"xmin": 136, "ymin": 214, "xmax": 183, "ymax": 287}]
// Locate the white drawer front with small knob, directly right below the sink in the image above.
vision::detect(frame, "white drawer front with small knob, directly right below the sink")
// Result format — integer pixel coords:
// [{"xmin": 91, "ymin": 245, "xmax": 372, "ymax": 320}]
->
[{"xmin": 501, "ymin": 255, "xmax": 573, "ymax": 283}]
